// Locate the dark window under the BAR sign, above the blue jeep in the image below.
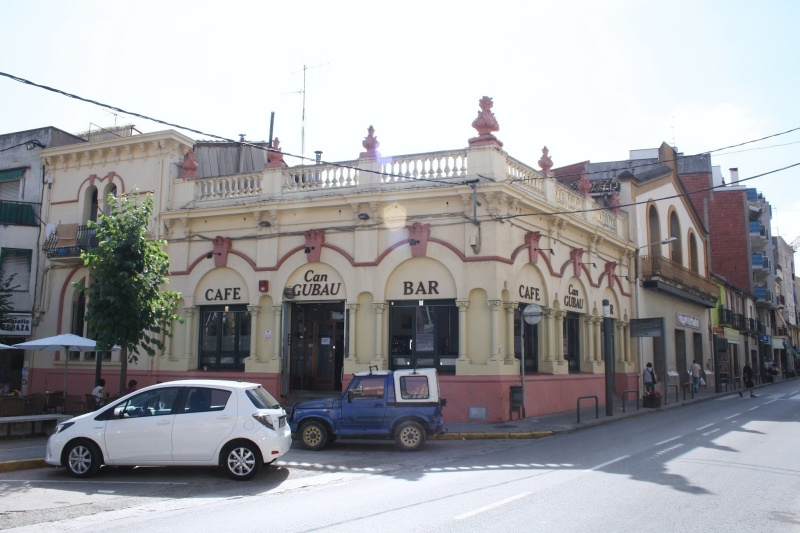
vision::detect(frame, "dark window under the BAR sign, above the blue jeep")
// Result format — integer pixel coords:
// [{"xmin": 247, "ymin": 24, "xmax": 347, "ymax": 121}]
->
[{"xmin": 389, "ymin": 300, "xmax": 458, "ymax": 374}]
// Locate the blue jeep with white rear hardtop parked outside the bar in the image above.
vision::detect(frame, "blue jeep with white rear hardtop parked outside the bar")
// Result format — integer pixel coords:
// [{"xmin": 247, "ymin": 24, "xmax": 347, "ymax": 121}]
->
[{"xmin": 289, "ymin": 368, "xmax": 447, "ymax": 451}]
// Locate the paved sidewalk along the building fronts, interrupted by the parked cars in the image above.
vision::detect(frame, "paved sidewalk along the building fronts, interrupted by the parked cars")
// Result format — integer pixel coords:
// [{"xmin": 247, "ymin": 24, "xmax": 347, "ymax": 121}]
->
[{"xmin": 0, "ymin": 381, "xmax": 782, "ymax": 473}]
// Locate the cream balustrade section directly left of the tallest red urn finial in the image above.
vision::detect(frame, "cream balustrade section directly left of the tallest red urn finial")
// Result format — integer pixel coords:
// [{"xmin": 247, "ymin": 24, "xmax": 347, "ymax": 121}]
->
[{"xmin": 379, "ymin": 150, "xmax": 467, "ymax": 183}]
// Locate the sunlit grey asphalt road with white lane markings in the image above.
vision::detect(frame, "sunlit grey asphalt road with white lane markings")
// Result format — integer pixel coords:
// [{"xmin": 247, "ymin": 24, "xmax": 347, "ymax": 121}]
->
[{"xmin": 0, "ymin": 381, "xmax": 800, "ymax": 533}]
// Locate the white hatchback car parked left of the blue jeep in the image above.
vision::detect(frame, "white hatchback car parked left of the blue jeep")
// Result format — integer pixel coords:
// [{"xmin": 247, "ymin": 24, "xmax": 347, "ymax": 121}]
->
[{"xmin": 45, "ymin": 380, "xmax": 292, "ymax": 480}]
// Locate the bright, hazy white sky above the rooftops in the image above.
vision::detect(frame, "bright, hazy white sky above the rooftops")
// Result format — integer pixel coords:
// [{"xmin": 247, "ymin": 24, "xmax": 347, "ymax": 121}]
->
[{"xmin": 0, "ymin": 0, "xmax": 800, "ymax": 242}]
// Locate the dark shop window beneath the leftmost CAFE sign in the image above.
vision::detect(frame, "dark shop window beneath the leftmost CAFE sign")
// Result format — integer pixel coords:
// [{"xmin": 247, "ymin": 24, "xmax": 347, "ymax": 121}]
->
[{"xmin": 198, "ymin": 305, "xmax": 251, "ymax": 370}]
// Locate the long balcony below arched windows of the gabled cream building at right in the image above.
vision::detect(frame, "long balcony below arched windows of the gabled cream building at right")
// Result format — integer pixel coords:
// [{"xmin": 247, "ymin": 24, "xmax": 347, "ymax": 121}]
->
[{"xmin": 640, "ymin": 255, "xmax": 719, "ymax": 307}]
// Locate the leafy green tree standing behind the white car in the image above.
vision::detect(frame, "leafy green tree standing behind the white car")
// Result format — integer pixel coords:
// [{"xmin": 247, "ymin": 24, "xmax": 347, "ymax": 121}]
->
[{"xmin": 73, "ymin": 190, "xmax": 183, "ymax": 394}]
